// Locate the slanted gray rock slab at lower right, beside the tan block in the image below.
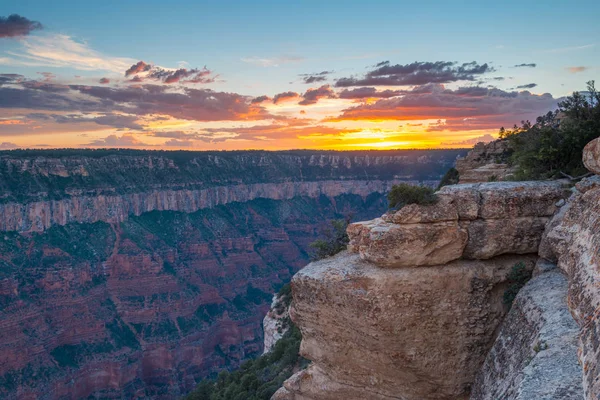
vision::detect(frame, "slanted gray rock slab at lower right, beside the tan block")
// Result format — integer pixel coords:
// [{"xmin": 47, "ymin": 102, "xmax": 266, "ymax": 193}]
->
[{"xmin": 471, "ymin": 270, "xmax": 583, "ymax": 400}]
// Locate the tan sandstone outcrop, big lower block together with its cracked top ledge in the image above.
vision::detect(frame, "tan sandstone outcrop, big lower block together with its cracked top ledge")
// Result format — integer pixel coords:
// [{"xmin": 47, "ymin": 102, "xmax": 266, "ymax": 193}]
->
[{"xmin": 278, "ymin": 182, "xmax": 569, "ymax": 400}]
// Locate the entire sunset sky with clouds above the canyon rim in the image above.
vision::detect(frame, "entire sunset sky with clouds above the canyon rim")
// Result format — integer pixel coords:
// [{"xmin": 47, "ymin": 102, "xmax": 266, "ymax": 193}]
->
[{"xmin": 0, "ymin": 0, "xmax": 600, "ymax": 150}]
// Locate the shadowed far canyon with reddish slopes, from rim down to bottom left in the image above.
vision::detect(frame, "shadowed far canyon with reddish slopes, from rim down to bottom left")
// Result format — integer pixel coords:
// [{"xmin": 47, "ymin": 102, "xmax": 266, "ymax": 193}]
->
[{"xmin": 0, "ymin": 150, "xmax": 465, "ymax": 399}]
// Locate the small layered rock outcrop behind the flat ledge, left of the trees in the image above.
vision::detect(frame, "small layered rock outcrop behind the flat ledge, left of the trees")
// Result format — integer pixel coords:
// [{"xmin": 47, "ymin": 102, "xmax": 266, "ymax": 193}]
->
[{"xmin": 456, "ymin": 140, "xmax": 513, "ymax": 183}]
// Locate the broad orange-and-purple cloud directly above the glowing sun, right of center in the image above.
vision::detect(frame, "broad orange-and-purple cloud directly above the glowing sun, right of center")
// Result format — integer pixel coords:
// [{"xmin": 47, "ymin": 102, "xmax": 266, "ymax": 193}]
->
[{"xmin": 327, "ymin": 85, "xmax": 559, "ymax": 131}]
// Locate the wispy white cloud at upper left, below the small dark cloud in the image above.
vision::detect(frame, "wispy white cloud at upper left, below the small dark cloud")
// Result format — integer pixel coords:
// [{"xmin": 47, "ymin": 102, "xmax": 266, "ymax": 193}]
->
[{"xmin": 0, "ymin": 34, "xmax": 134, "ymax": 73}]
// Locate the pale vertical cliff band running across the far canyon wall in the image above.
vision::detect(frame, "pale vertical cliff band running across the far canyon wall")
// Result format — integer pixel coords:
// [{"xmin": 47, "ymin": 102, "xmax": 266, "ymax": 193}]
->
[{"xmin": 0, "ymin": 180, "xmax": 406, "ymax": 232}]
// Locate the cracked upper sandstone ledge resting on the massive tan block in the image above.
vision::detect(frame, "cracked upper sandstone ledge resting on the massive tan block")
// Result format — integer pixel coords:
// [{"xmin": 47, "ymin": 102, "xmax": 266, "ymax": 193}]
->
[{"xmin": 348, "ymin": 182, "xmax": 567, "ymax": 268}]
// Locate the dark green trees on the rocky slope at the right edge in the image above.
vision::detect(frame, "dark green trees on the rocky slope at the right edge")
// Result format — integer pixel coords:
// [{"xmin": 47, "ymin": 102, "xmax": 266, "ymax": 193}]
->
[{"xmin": 500, "ymin": 81, "xmax": 600, "ymax": 180}]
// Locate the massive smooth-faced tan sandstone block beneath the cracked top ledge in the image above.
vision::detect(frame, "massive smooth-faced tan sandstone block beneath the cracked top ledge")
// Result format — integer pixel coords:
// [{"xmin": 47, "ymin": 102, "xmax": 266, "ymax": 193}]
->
[{"xmin": 285, "ymin": 252, "xmax": 535, "ymax": 400}]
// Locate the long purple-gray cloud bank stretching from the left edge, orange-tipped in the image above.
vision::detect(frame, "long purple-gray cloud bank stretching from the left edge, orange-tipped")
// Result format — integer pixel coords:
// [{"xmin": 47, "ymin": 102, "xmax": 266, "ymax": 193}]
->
[{"xmin": 0, "ymin": 81, "xmax": 268, "ymax": 121}]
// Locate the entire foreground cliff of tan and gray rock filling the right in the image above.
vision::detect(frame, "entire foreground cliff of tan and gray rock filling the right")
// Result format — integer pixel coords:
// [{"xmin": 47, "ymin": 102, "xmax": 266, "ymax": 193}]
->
[{"xmin": 272, "ymin": 138, "xmax": 600, "ymax": 400}]
